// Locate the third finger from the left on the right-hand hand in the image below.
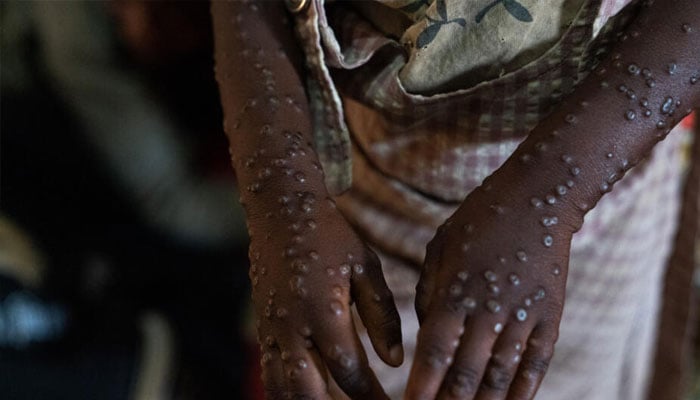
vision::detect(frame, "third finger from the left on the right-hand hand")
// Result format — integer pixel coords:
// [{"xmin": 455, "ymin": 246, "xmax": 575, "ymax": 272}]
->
[{"xmin": 475, "ymin": 322, "xmax": 532, "ymax": 400}]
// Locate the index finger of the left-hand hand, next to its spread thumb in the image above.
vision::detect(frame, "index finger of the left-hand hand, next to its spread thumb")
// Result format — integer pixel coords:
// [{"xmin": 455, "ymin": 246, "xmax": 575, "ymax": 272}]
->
[{"xmin": 313, "ymin": 312, "xmax": 388, "ymax": 400}]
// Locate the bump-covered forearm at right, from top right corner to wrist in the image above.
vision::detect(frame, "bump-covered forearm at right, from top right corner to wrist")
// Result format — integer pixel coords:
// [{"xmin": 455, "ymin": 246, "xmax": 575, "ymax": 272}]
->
[{"xmin": 484, "ymin": 0, "xmax": 700, "ymax": 231}]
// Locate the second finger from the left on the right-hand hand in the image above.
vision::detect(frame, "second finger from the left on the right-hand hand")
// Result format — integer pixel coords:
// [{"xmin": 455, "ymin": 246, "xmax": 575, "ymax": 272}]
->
[{"xmin": 426, "ymin": 317, "xmax": 498, "ymax": 400}]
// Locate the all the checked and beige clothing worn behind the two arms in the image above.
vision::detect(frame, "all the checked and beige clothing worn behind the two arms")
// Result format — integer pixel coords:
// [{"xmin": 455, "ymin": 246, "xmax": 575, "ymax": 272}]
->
[{"xmin": 298, "ymin": 0, "xmax": 684, "ymax": 400}]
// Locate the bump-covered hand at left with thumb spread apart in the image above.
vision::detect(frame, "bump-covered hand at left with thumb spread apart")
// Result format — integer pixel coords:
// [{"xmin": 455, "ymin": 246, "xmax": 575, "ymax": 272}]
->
[{"xmin": 250, "ymin": 198, "xmax": 403, "ymax": 399}]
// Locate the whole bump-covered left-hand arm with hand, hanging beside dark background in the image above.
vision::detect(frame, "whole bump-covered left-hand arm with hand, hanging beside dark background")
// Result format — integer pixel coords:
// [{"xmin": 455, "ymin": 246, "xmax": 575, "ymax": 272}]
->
[{"xmin": 212, "ymin": 1, "xmax": 403, "ymax": 399}]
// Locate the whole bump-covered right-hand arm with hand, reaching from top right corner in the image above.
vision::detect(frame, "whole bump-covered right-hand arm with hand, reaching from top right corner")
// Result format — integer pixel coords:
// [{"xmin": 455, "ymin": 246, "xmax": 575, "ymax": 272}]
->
[{"xmin": 407, "ymin": 0, "xmax": 700, "ymax": 399}]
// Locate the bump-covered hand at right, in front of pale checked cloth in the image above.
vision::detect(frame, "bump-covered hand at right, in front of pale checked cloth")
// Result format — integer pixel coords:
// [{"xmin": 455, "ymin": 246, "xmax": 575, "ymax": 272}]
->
[{"xmin": 406, "ymin": 185, "xmax": 571, "ymax": 399}]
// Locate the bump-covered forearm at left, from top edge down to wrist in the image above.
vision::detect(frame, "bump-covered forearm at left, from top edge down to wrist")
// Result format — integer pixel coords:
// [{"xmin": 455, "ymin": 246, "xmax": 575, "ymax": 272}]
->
[{"xmin": 212, "ymin": 1, "xmax": 327, "ymax": 228}]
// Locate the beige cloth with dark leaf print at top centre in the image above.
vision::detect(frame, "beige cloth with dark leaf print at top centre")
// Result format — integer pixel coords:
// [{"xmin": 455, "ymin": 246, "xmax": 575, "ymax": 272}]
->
[{"xmin": 356, "ymin": 0, "xmax": 584, "ymax": 94}]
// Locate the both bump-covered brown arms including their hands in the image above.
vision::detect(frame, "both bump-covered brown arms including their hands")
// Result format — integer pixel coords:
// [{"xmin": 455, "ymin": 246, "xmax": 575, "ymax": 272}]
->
[{"xmin": 212, "ymin": 0, "xmax": 700, "ymax": 400}]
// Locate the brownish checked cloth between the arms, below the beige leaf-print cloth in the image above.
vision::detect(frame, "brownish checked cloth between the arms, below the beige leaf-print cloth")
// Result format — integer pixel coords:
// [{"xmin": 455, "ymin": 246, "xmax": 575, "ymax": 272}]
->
[{"xmin": 326, "ymin": 1, "xmax": 634, "ymax": 265}]
